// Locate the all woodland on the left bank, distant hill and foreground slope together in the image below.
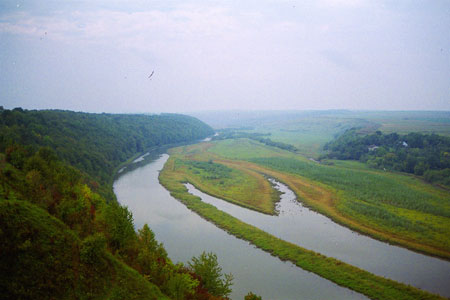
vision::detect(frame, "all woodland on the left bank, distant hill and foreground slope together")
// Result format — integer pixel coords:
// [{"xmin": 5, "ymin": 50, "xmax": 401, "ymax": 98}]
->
[{"xmin": 0, "ymin": 109, "xmax": 250, "ymax": 299}]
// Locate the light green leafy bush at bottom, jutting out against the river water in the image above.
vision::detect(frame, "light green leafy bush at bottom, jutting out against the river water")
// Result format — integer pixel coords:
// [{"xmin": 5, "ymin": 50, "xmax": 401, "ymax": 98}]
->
[{"xmin": 189, "ymin": 252, "xmax": 233, "ymax": 297}]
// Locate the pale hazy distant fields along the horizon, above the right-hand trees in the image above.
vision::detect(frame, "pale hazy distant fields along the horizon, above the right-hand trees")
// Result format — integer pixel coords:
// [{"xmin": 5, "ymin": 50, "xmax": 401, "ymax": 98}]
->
[{"xmin": 193, "ymin": 110, "xmax": 450, "ymax": 158}]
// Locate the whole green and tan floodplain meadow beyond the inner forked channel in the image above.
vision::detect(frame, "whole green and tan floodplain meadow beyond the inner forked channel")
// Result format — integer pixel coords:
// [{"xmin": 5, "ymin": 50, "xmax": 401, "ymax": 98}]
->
[{"xmin": 173, "ymin": 139, "xmax": 450, "ymax": 259}]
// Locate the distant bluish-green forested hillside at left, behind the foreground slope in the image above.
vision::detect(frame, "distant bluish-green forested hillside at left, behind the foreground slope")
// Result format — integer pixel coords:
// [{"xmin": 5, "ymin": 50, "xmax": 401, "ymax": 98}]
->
[{"xmin": 0, "ymin": 108, "xmax": 213, "ymax": 197}]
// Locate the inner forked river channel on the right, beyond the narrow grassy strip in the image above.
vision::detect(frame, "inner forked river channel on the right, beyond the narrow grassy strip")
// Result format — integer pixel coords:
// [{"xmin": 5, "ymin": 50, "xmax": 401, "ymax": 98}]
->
[{"xmin": 186, "ymin": 179, "xmax": 450, "ymax": 297}]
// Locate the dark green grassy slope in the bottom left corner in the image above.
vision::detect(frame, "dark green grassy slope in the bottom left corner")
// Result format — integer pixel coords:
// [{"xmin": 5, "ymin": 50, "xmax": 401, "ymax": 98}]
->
[{"xmin": 0, "ymin": 199, "xmax": 167, "ymax": 299}]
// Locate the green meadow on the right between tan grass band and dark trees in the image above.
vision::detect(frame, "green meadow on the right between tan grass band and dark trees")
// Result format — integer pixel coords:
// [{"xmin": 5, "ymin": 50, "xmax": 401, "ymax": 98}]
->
[{"xmin": 250, "ymin": 157, "xmax": 450, "ymax": 254}]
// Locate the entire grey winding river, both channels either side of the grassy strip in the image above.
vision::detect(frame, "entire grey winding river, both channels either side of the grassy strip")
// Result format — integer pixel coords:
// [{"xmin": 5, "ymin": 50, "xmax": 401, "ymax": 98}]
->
[{"xmin": 114, "ymin": 154, "xmax": 450, "ymax": 299}]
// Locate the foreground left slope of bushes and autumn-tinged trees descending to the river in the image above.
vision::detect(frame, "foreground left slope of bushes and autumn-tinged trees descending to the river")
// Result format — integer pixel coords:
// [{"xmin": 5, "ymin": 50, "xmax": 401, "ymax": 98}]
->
[{"xmin": 0, "ymin": 148, "xmax": 230, "ymax": 299}]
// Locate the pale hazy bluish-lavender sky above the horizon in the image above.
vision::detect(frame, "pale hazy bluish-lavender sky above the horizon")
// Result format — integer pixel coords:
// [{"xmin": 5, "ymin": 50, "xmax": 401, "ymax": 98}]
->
[{"xmin": 0, "ymin": 0, "xmax": 450, "ymax": 112}]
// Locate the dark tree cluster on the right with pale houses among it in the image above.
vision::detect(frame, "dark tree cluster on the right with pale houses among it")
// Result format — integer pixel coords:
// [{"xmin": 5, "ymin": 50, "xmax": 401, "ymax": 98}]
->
[{"xmin": 324, "ymin": 129, "xmax": 450, "ymax": 186}]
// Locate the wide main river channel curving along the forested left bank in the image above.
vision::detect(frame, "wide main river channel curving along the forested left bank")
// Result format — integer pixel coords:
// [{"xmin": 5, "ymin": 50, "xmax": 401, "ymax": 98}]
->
[{"xmin": 114, "ymin": 154, "xmax": 367, "ymax": 300}]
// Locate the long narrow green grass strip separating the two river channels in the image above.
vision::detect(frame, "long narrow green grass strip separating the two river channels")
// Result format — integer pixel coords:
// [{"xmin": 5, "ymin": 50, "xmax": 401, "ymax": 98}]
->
[{"xmin": 159, "ymin": 154, "xmax": 440, "ymax": 299}]
